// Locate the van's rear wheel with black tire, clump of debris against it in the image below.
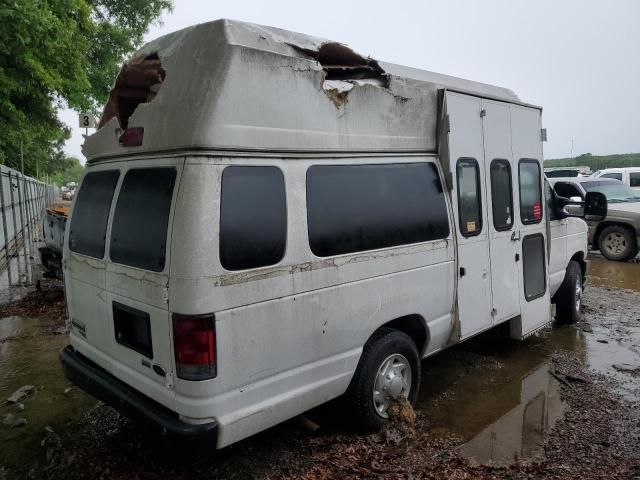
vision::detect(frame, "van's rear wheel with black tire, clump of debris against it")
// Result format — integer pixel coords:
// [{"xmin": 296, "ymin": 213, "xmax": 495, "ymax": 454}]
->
[{"xmin": 345, "ymin": 328, "xmax": 420, "ymax": 433}]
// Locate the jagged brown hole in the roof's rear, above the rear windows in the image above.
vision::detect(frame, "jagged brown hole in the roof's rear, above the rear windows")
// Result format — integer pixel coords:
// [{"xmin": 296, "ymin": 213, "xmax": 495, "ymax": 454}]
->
[{"xmin": 98, "ymin": 53, "xmax": 166, "ymax": 129}]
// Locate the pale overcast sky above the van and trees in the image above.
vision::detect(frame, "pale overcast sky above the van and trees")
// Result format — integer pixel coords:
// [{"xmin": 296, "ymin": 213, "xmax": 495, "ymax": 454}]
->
[{"xmin": 61, "ymin": 0, "xmax": 640, "ymax": 162}]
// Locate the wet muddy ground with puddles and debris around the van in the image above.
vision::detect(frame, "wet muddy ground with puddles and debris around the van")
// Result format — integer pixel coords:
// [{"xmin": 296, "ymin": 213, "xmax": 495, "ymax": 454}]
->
[{"xmin": 0, "ymin": 259, "xmax": 640, "ymax": 480}]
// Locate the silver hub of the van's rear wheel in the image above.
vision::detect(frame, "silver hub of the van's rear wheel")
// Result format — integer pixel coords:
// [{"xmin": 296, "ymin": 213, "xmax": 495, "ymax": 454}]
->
[{"xmin": 373, "ymin": 353, "xmax": 411, "ymax": 418}]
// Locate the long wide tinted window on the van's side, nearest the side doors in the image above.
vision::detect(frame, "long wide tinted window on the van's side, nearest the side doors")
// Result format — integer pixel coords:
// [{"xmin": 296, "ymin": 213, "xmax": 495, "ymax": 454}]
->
[{"xmin": 307, "ymin": 163, "xmax": 449, "ymax": 257}]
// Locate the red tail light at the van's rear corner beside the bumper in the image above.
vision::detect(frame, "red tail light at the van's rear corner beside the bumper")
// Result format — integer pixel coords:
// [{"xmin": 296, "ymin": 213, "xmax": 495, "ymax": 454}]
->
[{"xmin": 173, "ymin": 313, "xmax": 218, "ymax": 380}]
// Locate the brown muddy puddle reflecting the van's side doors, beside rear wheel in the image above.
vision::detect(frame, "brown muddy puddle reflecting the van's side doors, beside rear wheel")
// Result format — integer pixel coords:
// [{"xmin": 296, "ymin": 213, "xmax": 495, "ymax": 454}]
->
[{"xmin": 417, "ymin": 327, "xmax": 585, "ymax": 465}]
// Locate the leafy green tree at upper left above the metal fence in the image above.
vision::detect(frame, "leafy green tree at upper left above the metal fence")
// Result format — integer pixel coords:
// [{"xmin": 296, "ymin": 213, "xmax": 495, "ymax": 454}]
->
[{"xmin": 0, "ymin": 0, "xmax": 172, "ymax": 175}]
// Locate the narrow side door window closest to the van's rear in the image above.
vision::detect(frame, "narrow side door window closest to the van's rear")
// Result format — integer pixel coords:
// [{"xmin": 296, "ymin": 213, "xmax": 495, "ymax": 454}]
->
[{"xmin": 456, "ymin": 158, "xmax": 482, "ymax": 237}]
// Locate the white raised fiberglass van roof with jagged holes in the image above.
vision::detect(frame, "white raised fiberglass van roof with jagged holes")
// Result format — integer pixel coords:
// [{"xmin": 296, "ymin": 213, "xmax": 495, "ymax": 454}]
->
[{"xmin": 83, "ymin": 20, "xmax": 520, "ymax": 160}]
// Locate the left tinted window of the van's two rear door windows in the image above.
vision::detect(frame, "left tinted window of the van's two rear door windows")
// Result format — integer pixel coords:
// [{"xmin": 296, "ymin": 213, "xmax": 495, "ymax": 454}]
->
[{"xmin": 69, "ymin": 170, "xmax": 120, "ymax": 258}]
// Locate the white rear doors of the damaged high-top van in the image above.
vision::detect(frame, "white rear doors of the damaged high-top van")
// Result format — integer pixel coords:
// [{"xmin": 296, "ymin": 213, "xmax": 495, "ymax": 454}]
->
[{"xmin": 65, "ymin": 158, "xmax": 184, "ymax": 398}]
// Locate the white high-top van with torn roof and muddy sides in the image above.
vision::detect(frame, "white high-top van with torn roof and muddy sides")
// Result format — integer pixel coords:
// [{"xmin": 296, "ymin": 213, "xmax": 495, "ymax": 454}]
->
[{"xmin": 61, "ymin": 20, "xmax": 606, "ymax": 448}]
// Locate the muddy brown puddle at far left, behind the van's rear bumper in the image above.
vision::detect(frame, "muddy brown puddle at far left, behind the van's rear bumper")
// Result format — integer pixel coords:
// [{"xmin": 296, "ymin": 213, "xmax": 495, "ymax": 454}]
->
[{"xmin": 0, "ymin": 317, "xmax": 96, "ymax": 467}]
